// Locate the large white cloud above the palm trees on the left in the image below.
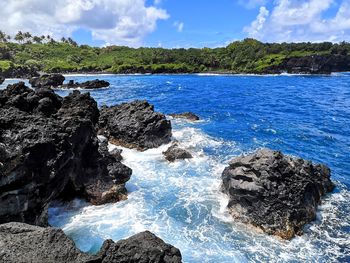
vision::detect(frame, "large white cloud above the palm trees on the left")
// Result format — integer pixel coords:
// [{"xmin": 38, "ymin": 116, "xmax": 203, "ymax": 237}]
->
[{"xmin": 0, "ymin": 0, "xmax": 169, "ymax": 46}]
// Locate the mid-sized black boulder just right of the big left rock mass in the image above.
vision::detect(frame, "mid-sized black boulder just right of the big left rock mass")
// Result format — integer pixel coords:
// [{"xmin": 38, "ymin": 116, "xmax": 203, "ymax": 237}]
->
[{"xmin": 99, "ymin": 101, "xmax": 171, "ymax": 150}]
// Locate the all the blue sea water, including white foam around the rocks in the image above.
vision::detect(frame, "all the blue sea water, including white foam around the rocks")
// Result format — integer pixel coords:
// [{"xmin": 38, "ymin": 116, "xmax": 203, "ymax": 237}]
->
[{"xmin": 1, "ymin": 73, "xmax": 350, "ymax": 262}]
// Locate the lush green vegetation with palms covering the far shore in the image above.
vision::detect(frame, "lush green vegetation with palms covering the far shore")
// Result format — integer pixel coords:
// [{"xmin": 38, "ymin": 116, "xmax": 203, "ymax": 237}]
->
[{"xmin": 0, "ymin": 31, "xmax": 350, "ymax": 73}]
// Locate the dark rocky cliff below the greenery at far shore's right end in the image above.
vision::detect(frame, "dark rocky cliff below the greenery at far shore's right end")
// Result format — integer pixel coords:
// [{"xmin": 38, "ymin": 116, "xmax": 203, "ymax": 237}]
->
[{"xmin": 264, "ymin": 54, "xmax": 350, "ymax": 74}]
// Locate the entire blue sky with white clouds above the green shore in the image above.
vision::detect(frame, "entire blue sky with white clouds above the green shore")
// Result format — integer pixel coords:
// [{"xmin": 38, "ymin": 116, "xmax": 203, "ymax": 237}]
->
[{"xmin": 0, "ymin": 0, "xmax": 350, "ymax": 48}]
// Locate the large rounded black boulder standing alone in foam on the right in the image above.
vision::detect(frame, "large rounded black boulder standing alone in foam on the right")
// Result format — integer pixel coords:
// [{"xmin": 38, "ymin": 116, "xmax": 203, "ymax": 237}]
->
[{"xmin": 222, "ymin": 149, "xmax": 334, "ymax": 239}]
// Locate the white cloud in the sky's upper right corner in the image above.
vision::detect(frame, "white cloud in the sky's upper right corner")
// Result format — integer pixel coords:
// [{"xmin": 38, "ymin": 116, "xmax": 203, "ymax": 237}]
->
[{"xmin": 244, "ymin": 0, "xmax": 350, "ymax": 42}]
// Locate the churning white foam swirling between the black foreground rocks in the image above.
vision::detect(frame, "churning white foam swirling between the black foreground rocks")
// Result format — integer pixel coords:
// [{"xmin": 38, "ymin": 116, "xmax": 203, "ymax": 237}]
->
[{"xmin": 50, "ymin": 126, "xmax": 350, "ymax": 262}]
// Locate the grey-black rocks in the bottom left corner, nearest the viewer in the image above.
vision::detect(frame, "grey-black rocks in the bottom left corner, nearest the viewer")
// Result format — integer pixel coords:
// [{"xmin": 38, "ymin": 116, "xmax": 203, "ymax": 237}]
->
[{"xmin": 0, "ymin": 223, "xmax": 181, "ymax": 263}]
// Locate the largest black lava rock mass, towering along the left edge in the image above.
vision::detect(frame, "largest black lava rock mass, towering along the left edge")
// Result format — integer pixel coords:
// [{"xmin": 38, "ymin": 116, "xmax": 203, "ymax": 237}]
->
[{"xmin": 0, "ymin": 82, "xmax": 131, "ymax": 225}]
